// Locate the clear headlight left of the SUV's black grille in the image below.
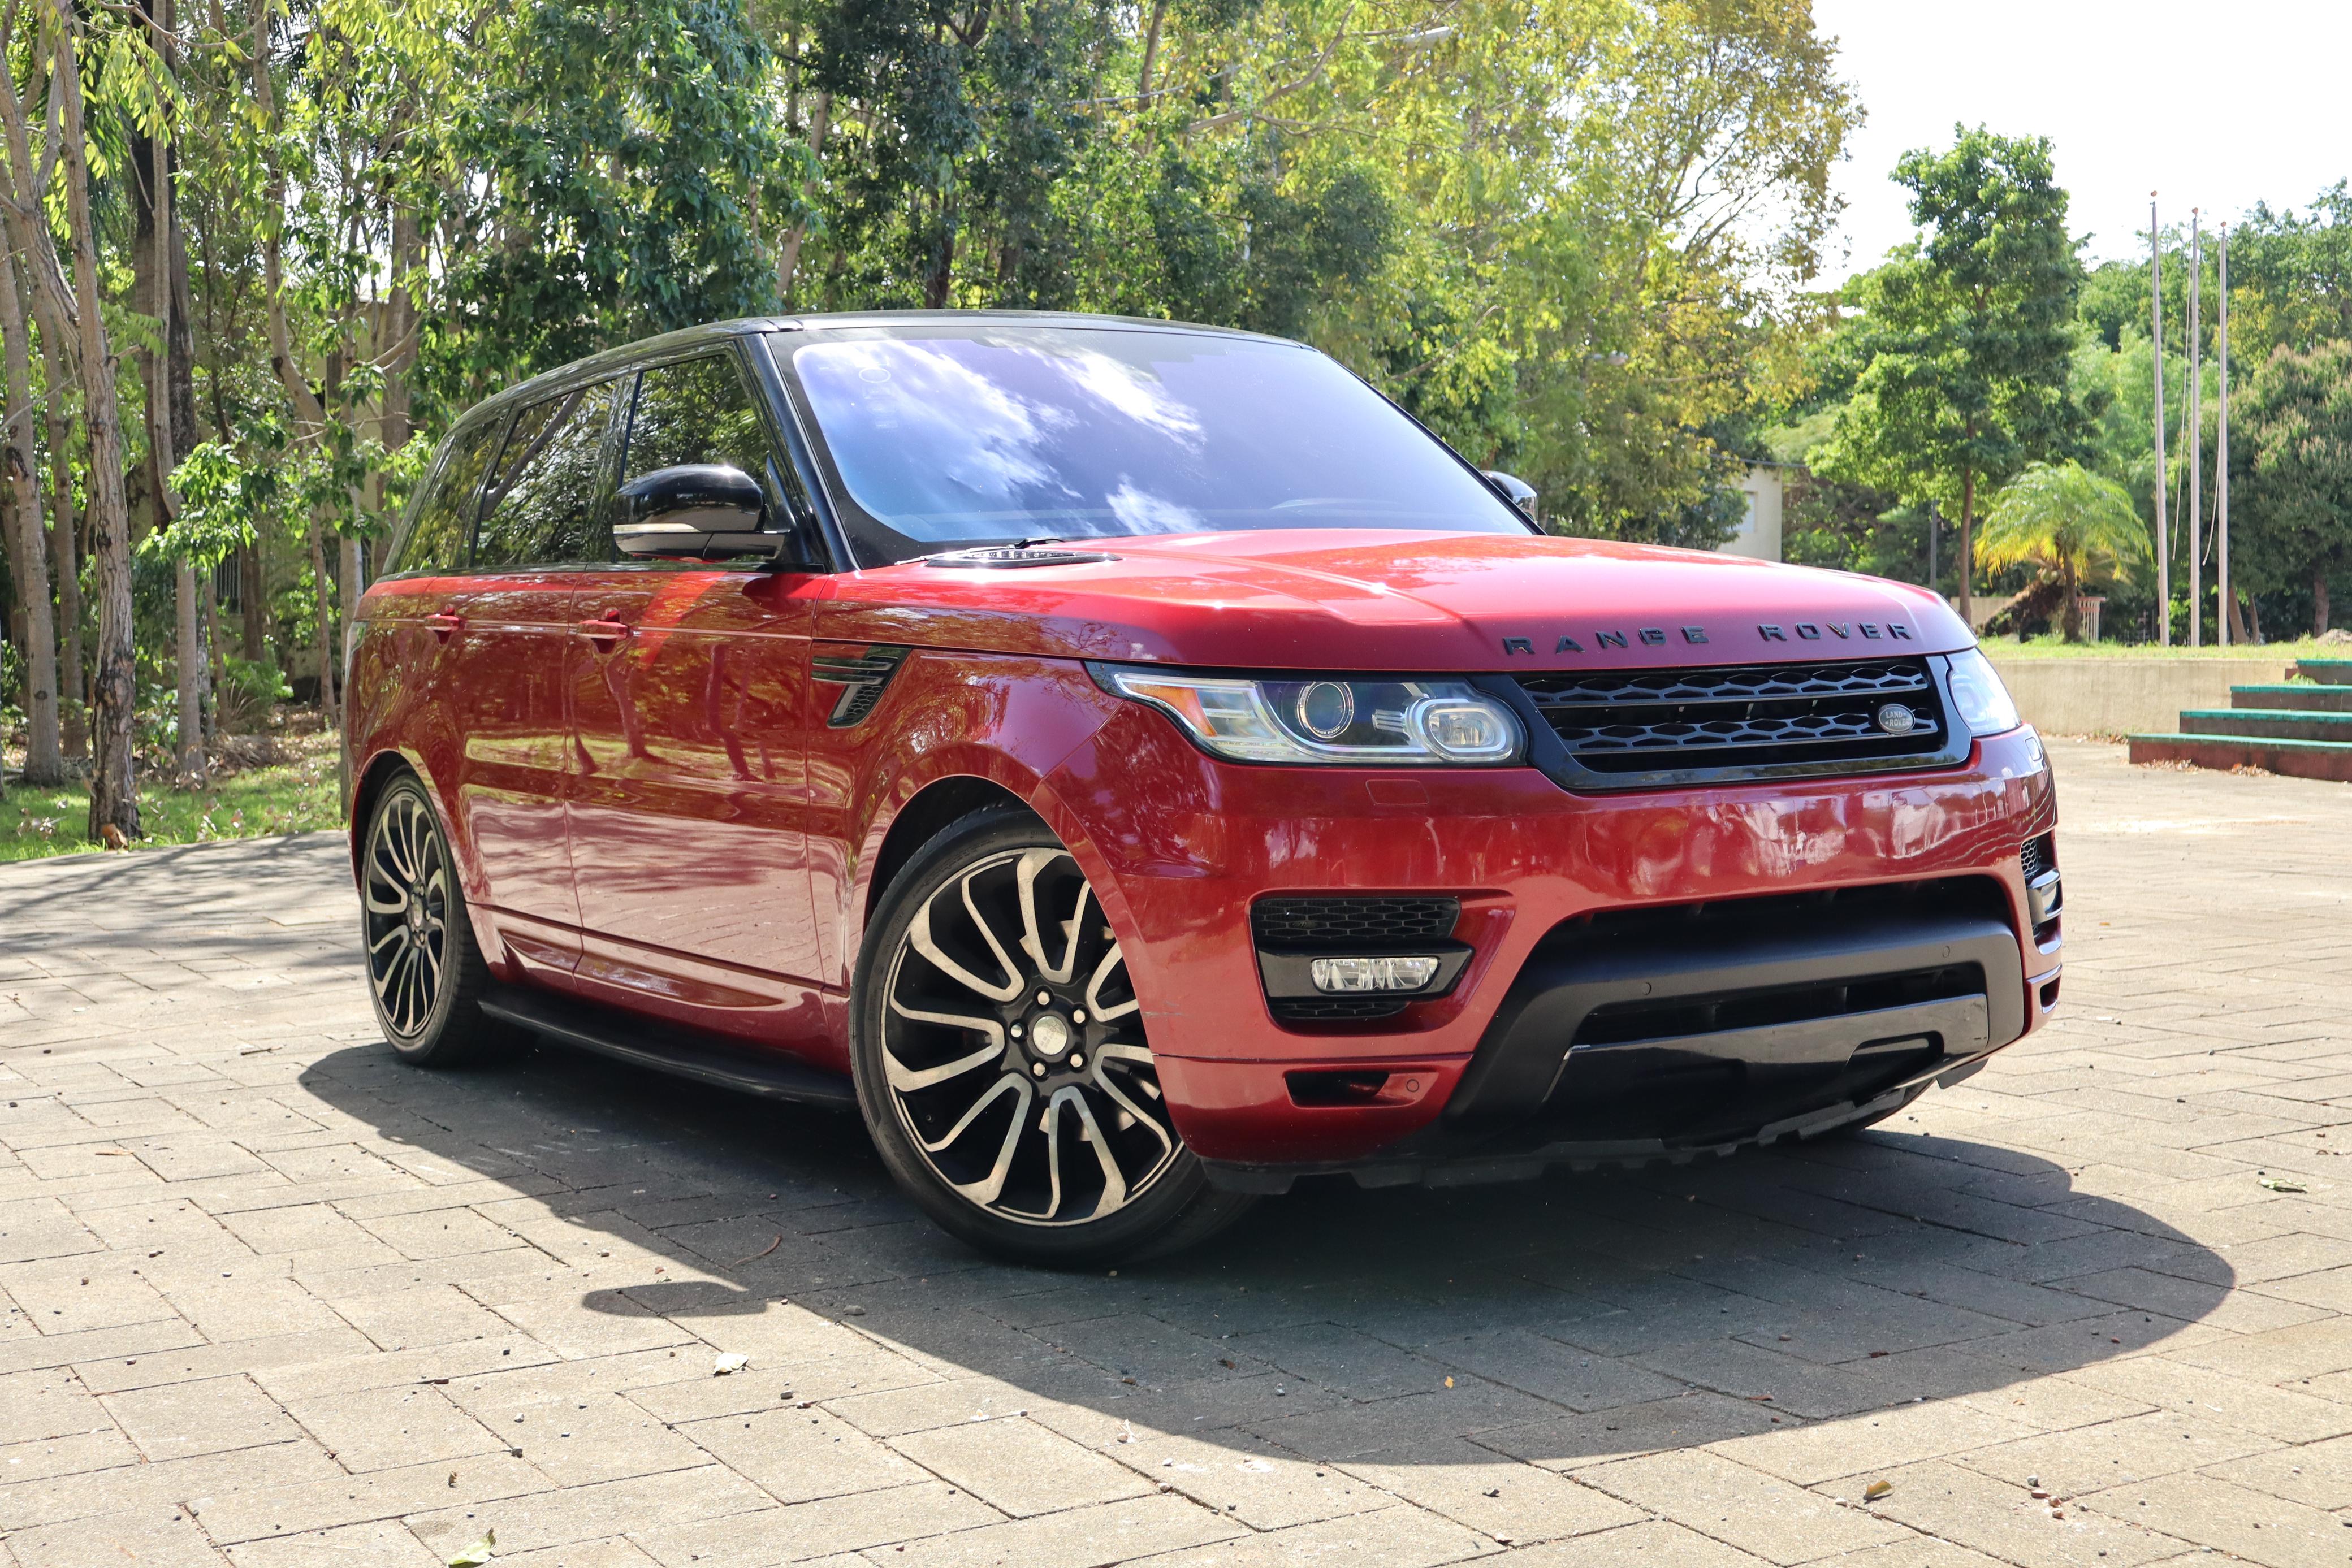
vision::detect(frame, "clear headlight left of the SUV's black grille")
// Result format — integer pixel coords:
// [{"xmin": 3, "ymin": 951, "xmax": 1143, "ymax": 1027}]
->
[{"xmin": 1096, "ymin": 668, "xmax": 1522, "ymax": 766}]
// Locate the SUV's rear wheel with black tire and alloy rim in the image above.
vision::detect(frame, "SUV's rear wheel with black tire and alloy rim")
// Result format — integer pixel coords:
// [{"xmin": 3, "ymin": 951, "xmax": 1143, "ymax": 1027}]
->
[{"xmin": 360, "ymin": 773, "xmax": 508, "ymax": 1067}]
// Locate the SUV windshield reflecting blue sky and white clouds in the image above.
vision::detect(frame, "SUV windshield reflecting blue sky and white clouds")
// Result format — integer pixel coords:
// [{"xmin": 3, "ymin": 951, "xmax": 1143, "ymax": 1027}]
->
[{"xmin": 779, "ymin": 327, "xmax": 1527, "ymax": 560}]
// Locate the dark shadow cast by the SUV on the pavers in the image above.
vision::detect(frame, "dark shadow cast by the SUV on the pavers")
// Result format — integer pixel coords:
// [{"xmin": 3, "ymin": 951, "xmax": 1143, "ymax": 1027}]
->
[{"xmin": 301, "ymin": 1044, "xmax": 2234, "ymax": 1467}]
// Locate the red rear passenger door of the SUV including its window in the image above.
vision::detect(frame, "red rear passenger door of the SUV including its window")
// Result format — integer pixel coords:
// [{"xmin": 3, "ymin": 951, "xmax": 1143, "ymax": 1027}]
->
[{"xmin": 452, "ymin": 381, "xmax": 619, "ymax": 973}]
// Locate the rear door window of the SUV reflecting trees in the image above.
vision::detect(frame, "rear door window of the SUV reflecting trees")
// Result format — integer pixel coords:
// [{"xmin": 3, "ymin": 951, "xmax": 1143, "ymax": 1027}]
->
[{"xmin": 473, "ymin": 381, "xmax": 619, "ymax": 566}]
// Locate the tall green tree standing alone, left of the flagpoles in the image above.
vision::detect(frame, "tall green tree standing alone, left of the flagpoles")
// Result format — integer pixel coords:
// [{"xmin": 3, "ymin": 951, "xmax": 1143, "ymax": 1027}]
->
[{"xmin": 1823, "ymin": 127, "xmax": 2084, "ymax": 618}]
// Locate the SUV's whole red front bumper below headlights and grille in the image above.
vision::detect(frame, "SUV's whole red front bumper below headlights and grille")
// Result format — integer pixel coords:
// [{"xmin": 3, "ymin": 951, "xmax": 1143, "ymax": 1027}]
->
[{"xmin": 1049, "ymin": 710, "xmax": 2058, "ymax": 1187}]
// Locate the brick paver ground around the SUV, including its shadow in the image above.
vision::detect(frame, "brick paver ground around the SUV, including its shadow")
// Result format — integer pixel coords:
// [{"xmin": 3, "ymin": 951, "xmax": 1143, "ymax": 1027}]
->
[{"xmin": 0, "ymin": 745, "xmax": 2352, "ymax": 1568}]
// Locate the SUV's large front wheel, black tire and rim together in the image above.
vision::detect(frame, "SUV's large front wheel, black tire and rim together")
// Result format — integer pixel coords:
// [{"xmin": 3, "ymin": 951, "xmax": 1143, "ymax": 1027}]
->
[{"xmin": 849, "ymin": 807, "xmax": 1251, "ymax": 1267}]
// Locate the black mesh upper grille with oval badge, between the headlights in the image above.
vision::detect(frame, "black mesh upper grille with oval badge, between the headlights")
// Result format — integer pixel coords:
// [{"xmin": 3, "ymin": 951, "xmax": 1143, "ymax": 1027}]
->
[{"xmin": 1519, "ymin": 658, "xmax": 1947, "ymax": 787}]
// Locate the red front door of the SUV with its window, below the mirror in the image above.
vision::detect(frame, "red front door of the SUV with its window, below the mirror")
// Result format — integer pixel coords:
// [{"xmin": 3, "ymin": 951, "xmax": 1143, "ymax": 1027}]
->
[{"xmin": 569, "ymin": 345, "xmax": 816, "ymax": 1039}]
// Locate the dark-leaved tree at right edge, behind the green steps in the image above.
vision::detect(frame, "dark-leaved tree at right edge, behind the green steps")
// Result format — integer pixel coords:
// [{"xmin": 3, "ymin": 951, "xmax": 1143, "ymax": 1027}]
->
[{"xmin": 2230, "ymin": 339, "xmax": 2352, "ymax": 637}]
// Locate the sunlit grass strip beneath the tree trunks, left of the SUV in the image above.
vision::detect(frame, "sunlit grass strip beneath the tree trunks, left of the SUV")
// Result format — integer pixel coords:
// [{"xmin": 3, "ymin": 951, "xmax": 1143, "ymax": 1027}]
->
[{"xmin": 0, "ymin": 731, "xmax": 343, "ymax": 860}]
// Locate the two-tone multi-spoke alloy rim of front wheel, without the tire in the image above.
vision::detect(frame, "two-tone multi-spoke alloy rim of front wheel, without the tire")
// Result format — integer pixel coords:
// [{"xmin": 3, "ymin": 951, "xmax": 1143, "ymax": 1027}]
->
[{"xmin": 882, "ymin": 848, "xmax": 1183, "ymax": 1225}]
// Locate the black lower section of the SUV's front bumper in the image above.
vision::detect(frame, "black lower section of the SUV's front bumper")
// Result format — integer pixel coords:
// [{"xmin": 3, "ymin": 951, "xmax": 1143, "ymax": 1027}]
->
[{"xmin": 1209, "ymin": 884, "xmax": 2042, "ymax": 1192}]
